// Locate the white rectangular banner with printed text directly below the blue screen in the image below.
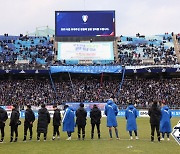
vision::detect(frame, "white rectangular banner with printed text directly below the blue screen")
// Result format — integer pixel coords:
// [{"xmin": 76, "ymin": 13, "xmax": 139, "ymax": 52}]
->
[{"xmin": 58, "ymin": 42, "xmax": 114, "ymax": 60}]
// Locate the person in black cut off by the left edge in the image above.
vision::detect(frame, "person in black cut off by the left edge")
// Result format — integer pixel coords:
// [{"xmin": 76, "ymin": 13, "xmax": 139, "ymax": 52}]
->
[{"xmin": 0, "ymin": 106, "xmax": 8, "ymax": 143}]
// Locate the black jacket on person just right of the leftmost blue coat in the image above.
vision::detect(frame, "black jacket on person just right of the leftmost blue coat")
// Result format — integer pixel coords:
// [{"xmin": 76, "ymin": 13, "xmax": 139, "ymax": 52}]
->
[{"xmin": 76, "ymin": 107, "xmax": 87, "ymax": 126}]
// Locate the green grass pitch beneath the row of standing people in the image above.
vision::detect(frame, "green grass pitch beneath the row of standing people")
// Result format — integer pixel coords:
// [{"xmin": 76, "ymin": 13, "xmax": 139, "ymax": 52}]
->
[{"xmin": 0, "ymin": 118, "xmax": 180, "ymax": 154}]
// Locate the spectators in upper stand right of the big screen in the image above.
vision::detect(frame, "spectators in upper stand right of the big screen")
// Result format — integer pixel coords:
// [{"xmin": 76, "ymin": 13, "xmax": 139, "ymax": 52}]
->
[{"xmin": 117, "ymin": 33, "xmax": 178, "ymax": 65}]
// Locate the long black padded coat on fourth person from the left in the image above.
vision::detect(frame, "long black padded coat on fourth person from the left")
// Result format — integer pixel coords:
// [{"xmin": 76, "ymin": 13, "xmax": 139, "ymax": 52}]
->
[{"xmin": 37, "ymin": 108, "xmax": 50, "ymax": 133}]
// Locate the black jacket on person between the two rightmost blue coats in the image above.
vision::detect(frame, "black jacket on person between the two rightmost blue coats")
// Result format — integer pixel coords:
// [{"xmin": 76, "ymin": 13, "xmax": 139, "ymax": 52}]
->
[{"xmin": 148, "ymin": 104, "xmax": 161, "ymax": 125}]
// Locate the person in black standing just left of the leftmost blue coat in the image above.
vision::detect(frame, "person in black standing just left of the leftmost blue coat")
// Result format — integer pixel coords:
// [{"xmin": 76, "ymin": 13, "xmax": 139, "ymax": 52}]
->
[{"xmin": 52, "ymin": 105, "xmax": 61, "ymax": 140}]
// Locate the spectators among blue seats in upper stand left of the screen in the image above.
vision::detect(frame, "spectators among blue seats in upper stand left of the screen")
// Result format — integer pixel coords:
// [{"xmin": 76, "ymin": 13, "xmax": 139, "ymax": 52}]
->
[{"xmin": 0, "ymin": 34, "xmax": 54, "ymax": 69}]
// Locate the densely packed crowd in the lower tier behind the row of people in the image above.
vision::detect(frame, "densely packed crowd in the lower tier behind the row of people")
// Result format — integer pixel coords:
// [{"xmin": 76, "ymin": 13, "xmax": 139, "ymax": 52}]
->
[{"xmin": 0, "ymin": 77, "xmax": 180, "ymax": 108}]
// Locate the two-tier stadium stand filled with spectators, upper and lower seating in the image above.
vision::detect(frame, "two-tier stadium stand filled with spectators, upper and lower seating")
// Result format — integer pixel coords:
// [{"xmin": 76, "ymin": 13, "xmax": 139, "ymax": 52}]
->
[{"xmin": 0, "ymin": 33, "xmax": 180, "ymax": 108}]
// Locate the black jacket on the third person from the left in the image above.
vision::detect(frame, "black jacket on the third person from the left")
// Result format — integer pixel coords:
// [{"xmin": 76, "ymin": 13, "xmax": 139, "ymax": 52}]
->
[{"xmin": 24, "ymin": 109, "xmax": 35, "ymax": 126}]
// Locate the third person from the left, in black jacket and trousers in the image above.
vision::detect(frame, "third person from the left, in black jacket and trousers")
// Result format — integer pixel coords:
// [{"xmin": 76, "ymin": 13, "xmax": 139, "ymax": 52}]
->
[{"xmin": 23, "ymin": 105, "xmax": 35, "ymax": 141}]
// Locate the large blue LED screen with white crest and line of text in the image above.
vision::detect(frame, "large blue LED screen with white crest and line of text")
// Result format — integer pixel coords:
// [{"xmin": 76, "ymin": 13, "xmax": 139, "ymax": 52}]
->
[{"xmin": 55, "ymin": 11, "xmax": 115, "ymax": 37}]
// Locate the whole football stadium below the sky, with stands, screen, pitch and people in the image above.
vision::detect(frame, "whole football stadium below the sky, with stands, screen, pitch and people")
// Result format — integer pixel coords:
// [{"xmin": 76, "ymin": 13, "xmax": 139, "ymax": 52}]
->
[{"xmin": 0, "ymin": 0, "xmax": 180, "ymax": 154}]
